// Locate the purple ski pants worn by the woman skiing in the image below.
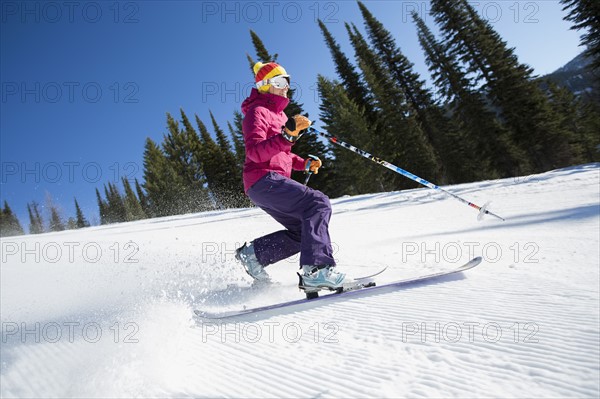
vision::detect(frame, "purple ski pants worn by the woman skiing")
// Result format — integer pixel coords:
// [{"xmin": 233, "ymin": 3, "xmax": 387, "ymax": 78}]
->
[{"xmin": 248, "ymin": 172, "xmax": 335, "ymax": 266}]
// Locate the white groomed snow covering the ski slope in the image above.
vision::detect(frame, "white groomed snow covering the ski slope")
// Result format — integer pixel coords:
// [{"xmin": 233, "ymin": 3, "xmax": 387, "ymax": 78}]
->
[{"xmin": 0, "ymin": 164, "xmax": 600, "ymax": 398}]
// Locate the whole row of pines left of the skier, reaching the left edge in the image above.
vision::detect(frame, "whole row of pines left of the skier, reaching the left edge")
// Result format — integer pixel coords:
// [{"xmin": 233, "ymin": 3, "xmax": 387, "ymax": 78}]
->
[{"xmin": 0, "ymin": 100, "xmax": 252, "ymax": 236}]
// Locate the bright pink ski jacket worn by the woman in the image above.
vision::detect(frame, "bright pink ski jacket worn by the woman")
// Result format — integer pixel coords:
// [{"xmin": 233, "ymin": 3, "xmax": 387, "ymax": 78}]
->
[{"xmin": 242, "ymin": 89, "xmax": 304, "ymax": 192}]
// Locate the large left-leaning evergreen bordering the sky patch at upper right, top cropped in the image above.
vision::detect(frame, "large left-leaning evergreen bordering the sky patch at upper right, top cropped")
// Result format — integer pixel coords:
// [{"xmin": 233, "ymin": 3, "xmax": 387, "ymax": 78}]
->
[{"xmin": 431, "ymin": 0, "xmax": 576, "ymax": 174}]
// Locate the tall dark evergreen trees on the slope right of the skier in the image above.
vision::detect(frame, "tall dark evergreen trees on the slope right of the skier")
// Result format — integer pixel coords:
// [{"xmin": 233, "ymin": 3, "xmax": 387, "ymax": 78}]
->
[{"xmin": 318, "ymin": 0, "xmax": 600, "ymax": 196}]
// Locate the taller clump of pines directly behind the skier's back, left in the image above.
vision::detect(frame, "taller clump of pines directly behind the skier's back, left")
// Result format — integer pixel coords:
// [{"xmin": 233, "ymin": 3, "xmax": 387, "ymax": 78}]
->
[{"xmin": 138, "ymin": 110, "xmax": 250, "ymax": 217}]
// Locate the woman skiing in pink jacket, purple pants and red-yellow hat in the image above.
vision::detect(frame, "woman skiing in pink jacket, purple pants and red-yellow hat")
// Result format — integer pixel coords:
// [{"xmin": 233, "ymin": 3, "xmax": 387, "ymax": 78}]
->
[{"xmin": 236, "ymin": 62, "xmax": 345, "ymax": 291}]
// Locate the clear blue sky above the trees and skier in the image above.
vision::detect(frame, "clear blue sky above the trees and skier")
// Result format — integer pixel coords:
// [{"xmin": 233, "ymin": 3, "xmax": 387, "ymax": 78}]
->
[{"xmin": 0, "ymin": 0, "xmax": 582, "ymax": 229}]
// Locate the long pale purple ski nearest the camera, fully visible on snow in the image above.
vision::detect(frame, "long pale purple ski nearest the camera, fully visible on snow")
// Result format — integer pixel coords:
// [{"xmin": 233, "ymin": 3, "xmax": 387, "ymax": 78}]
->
[{"xmin": 194, "ymin": 257, "xmax": 481, "ymax": 320}]
